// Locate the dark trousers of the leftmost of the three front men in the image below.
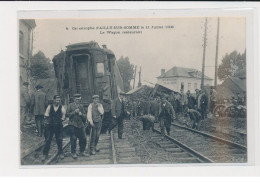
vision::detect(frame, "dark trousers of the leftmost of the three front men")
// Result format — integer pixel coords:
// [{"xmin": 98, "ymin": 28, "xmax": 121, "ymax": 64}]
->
[{"xmin": 43, "ymin": 124, "xmax": 63, "ymax": 155}]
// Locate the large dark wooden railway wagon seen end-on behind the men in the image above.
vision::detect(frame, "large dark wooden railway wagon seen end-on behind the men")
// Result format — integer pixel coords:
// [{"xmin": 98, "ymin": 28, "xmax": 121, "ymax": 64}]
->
[{"xmin": 53, "ymin": 41, "xmax": 123, "ymax": 112}]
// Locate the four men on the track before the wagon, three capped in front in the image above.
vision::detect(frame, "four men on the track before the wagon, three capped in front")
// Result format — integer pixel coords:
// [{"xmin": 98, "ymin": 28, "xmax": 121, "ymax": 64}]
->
[{"xmin": 43, "ymin": 94, "xmax": 124, "ymax": 161}]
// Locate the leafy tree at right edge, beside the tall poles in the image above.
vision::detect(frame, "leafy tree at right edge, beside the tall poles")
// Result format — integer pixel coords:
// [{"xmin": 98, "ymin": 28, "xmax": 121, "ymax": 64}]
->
[{"xmin": 218, "ymin": 50, "xmax": 246, "ymax": 80}]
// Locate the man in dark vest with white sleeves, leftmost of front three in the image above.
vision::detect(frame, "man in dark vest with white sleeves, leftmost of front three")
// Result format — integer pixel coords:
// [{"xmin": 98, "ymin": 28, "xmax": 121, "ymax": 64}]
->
[{"xmin": 42, "ymin": 95, "xmax": 66, "ymax": 161}]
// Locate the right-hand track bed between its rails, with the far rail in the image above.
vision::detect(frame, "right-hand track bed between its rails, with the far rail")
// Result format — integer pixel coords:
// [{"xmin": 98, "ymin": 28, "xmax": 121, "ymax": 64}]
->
[{"xmin": 162, "ymin": 123, "xmax": 247, "ymax": 163}]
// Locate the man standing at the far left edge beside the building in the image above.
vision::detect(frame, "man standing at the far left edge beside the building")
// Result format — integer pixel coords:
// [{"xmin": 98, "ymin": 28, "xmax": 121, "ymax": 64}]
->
[{"xmin": 20, "ymin": 82, "xmax": 30, "ymax": 124}]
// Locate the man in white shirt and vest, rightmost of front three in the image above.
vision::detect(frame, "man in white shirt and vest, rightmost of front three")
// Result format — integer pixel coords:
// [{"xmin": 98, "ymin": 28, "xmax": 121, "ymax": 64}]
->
[{"xmin": 87, "ymin": 95, "xmax": 104, "ymax": 155}]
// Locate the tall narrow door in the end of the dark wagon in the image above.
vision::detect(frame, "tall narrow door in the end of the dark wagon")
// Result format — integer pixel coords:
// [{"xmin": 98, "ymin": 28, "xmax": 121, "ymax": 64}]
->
[{"xmin": 73, "ymin": 55, "xmax": 93, "ymax": 104}]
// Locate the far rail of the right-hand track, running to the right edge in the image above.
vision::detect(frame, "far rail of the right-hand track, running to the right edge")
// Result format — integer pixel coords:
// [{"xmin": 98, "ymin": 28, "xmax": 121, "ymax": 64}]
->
[{"xmin": 171, "ymin": 123, "xmax": 247, "ymax": 152}]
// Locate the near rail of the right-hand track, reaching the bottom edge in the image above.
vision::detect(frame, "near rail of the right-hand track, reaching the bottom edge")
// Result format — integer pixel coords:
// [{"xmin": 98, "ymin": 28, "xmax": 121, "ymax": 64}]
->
[{"xmin": 154, "ymin": 128, "xmax": 215, "ymax": 163}]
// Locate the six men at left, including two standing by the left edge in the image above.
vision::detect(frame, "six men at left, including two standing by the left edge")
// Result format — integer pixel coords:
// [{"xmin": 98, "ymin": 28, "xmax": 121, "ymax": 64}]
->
[{"xmin": 21, "ymin": 82, "xmax": 125, "ymax": 161}]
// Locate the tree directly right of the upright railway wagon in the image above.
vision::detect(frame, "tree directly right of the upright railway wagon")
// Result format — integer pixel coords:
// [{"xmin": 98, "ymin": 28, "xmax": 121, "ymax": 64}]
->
[{"xmin": 117, "ymin": 56, "xmax": 134, "ymax": 92}]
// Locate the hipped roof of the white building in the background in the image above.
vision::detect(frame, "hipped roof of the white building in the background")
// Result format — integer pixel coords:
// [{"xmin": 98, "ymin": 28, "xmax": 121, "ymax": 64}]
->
[{"xmin": 157, "ymin": 66, "xmax": 212, "ymax": 80}]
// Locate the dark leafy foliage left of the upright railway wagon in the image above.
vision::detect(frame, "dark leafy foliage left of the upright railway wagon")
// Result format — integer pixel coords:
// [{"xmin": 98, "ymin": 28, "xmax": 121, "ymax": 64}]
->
[{"xmin": 30, "ymin": 51, "xmax": 54, "ymax": 80}]
